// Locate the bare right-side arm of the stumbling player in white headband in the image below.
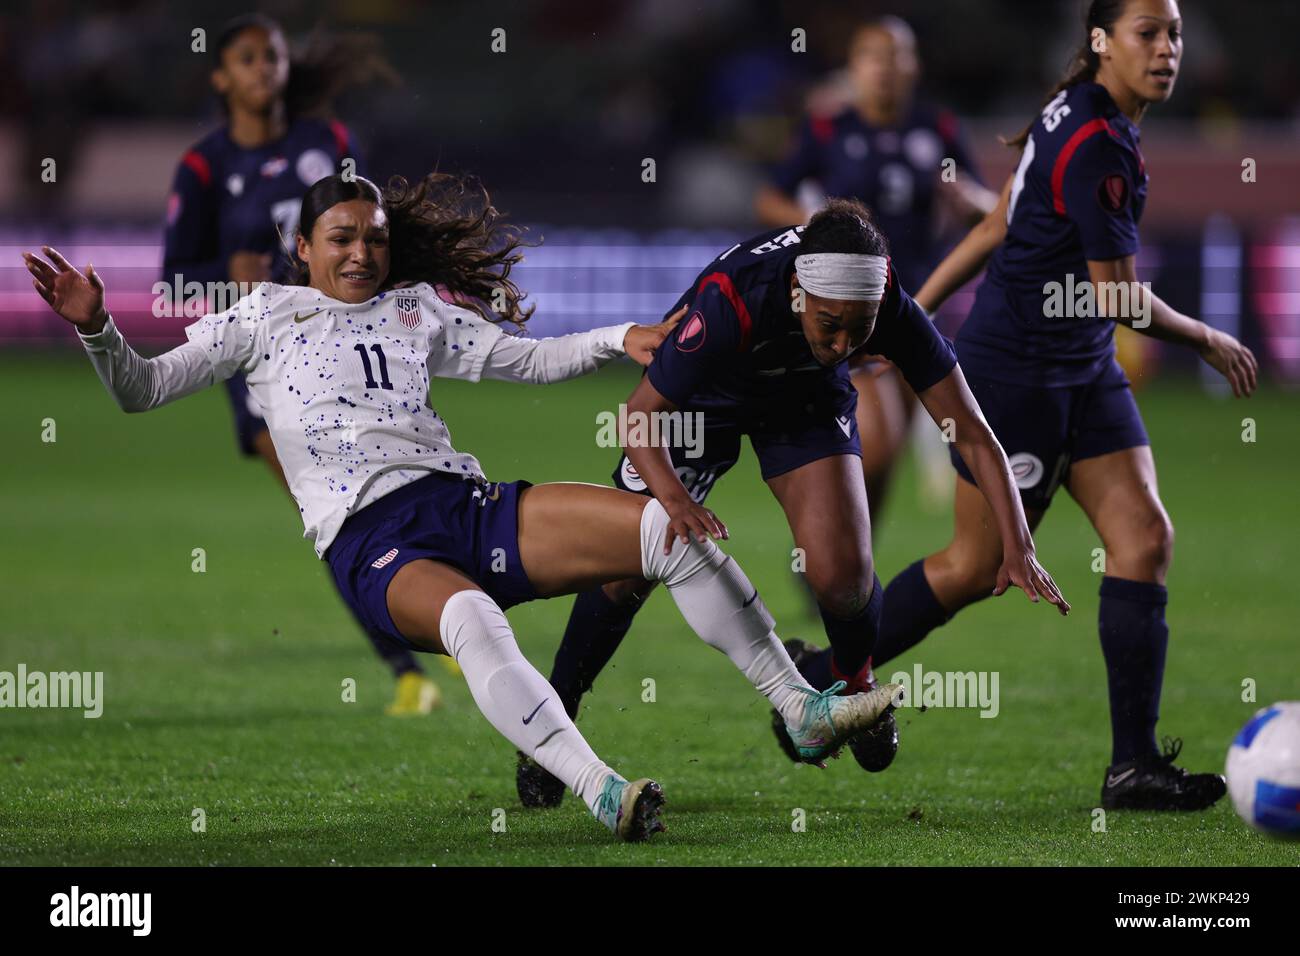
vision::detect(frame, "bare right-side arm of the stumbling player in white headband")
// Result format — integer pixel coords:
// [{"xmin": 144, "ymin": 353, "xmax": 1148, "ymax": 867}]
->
[{"xmin": 918, "ymin": 365, "xmax": 1070, "ymax": 615}]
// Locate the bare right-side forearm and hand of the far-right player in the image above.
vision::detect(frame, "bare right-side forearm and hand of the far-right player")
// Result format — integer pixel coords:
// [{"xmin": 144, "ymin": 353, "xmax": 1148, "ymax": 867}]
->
[{"xmin": 1088, "ymin": 256, "xmax": 1260, "ymax": 398}]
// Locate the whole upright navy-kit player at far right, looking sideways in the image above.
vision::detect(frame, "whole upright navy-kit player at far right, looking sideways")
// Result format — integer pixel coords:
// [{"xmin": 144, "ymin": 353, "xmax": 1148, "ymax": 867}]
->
[{"xmin": 875, "ymin": 0, "xmax": 1257, "ymax": 810}]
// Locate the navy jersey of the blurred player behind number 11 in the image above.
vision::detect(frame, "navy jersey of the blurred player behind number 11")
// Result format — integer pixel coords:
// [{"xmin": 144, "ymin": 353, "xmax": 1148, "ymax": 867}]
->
[{"xmin": 163, "ymin": 120, "xmax": 361, "ymax": 282}]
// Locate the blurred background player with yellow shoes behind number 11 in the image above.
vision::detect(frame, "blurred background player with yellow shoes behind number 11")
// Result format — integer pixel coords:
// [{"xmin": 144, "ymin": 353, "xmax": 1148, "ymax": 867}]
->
[{"xmin": 163, "ymin": 13, "xmax": 442, "ymax": 715}]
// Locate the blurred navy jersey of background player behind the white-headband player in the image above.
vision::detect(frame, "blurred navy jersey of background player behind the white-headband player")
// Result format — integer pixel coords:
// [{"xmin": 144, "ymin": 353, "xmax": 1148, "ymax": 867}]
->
[{"xmin": 771, "ymin": 103, "xmax": 979, "ymax": 289}]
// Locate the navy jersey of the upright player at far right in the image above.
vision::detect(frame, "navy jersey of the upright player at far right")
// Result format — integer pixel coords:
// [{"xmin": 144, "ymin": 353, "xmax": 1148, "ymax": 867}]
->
[{"xmin": 957, "ymin": 83, "xmax": 1147, "ymax": 386}]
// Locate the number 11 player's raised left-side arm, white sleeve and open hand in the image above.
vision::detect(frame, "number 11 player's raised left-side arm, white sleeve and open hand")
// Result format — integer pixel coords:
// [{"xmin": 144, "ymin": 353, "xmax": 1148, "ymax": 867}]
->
[{"xmin": 22, "ymin": 246, "xmax": 236, "ymax": 412}]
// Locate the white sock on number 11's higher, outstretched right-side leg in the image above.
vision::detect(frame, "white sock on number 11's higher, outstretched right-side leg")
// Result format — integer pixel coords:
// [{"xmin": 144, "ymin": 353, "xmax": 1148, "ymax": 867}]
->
[{"xmin": 641, "ymin": 498, "xmax": 813, "ymax": 726}]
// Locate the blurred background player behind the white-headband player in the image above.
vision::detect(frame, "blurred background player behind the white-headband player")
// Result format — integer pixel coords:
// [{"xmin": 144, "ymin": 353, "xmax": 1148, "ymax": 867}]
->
[{"xmin": 754, "ymin": 17, "xmax": 997, "ymax": 527}]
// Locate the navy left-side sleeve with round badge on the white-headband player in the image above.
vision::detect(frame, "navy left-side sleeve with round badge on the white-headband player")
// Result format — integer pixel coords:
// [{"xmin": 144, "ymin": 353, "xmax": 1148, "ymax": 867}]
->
[{"xmin": 646, "ymin": 282, "xmax": 748, "ymax": 408}]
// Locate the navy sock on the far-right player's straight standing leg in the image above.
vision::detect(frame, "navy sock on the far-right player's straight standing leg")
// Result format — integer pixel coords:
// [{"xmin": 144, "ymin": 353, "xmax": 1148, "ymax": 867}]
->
[{"xmin": 1097, "ymin": 578, "xmax": 1169, "ymax": 763}]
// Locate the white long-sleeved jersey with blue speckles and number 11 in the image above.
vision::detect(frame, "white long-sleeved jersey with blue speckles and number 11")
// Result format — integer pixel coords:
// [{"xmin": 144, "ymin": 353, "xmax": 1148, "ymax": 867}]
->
[{"xmin": 81, "ymin": 282, "xmax": 632, "ymax": 557}]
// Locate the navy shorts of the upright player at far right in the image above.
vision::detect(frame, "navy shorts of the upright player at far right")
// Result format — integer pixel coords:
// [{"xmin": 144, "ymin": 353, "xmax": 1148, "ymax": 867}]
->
[{"xmin": 948, "ymin": 360, "xmax": 1151, "ymax": 511}]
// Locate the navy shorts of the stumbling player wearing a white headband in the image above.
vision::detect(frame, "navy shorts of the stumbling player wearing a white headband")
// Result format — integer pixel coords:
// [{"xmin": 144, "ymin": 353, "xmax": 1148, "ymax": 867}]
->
[{"xmin": 614, "ymin": 392, "xmax": 862, "ymax": 505}]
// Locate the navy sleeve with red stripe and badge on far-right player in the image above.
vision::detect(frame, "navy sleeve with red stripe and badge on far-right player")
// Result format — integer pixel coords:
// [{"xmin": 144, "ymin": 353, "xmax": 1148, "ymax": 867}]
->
[{"xmin": 1053, "ymin": 131, "xmax": 1139, "ymax": 259}]
